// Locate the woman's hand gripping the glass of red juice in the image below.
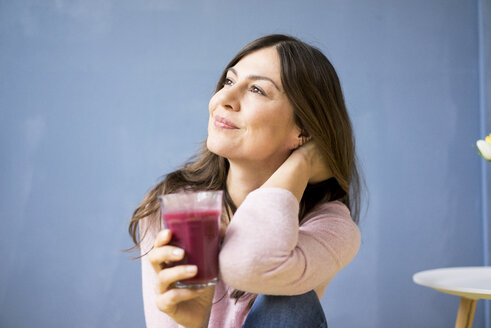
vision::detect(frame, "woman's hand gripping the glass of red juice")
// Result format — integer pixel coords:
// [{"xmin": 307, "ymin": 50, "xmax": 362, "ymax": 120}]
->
[{"xmin": 148, "ymin": 229, "xmax": 215, "ymax": 327}]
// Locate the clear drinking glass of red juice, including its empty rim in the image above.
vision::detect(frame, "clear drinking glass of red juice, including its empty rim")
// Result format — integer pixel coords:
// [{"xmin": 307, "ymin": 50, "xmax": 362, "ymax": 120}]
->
[{"xmin": 158, "ymin": 190, "xmax": 223, "ymax": 288}]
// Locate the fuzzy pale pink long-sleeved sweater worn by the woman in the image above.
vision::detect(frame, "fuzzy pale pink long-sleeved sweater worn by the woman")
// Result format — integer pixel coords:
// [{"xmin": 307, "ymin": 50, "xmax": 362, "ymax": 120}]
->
[{"xmin": 140, "ymin": 188, "xmax": 360, "ymax": 328}]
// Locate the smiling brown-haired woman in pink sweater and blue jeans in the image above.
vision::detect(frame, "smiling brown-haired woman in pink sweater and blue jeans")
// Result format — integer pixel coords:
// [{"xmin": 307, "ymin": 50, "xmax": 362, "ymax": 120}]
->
[{"xmin": 130, "ymin": 35, "xmax": 360, "ymax": 328}]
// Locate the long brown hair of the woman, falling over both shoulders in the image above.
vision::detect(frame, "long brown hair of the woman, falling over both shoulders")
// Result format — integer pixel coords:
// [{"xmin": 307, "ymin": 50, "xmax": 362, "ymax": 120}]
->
[{"xmin": 129, "ymin": 34, "xmax": 360, "ymax": 306}]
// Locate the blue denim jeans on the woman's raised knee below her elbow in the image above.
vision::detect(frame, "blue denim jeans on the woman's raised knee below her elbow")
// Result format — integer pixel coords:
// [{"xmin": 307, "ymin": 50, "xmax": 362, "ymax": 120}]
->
[{"xmin": 242, "ymin": 291, "xmax": 327, "ymax": 328}]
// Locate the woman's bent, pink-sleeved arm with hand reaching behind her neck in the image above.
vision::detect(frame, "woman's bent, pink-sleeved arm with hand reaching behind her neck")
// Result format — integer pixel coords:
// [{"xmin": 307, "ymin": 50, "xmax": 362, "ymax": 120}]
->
[{"xmin": 220, "ymin": 142, "xmax": 360, "ymax": 295}]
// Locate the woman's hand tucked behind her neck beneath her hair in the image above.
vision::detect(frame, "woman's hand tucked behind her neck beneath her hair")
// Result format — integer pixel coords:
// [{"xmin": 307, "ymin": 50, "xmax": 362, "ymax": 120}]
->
[{"xmin": 290, "ymin": 141, "xmax": 332, "ymax": 183}]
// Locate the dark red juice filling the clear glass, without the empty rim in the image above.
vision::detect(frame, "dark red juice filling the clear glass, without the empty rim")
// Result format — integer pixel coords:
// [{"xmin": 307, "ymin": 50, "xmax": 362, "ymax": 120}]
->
[{"xmin": 163, "ymin": 210, "xmax": 221, "ymax": 287}]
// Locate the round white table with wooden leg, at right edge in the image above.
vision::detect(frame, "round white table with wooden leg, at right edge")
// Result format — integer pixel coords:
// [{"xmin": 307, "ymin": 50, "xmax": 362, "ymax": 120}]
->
[{"xmin": 413, "ymin": 267, "xmax": 491, "ymax": 328}]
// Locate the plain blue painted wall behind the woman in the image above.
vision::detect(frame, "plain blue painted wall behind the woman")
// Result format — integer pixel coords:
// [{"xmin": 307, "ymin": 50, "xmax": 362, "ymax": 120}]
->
[{"xmin": 0, "ymin": 0, "xmax": 491, "ymax": 328}]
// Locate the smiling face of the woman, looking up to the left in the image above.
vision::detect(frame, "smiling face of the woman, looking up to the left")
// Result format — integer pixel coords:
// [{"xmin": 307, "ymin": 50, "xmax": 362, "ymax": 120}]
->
[{"xmin": 207, "ymin": 47, "xmax": 300, "ymax": 164}]
